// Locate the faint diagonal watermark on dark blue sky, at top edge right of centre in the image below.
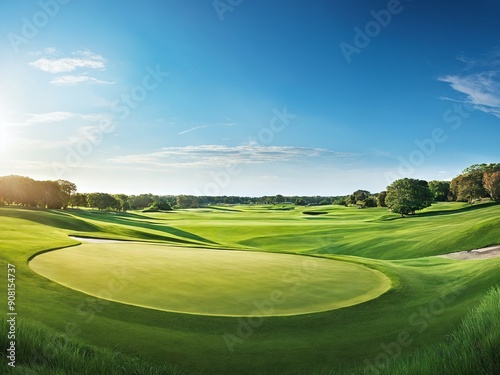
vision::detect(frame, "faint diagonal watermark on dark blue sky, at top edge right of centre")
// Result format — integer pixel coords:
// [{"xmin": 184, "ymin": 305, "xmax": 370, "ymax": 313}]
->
[{"xmin": 339, "ymin": 0, "xmax": 411, "ymax": 64}]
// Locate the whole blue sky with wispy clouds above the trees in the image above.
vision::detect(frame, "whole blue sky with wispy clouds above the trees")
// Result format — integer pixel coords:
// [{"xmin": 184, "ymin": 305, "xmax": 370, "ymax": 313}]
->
[{"xmin": 0, "ymin": 0, "xmax": 500, "ymax": 196}]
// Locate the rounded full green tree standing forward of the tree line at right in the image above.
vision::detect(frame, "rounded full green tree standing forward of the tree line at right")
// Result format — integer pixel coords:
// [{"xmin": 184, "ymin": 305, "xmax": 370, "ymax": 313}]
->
[{"xmin": 385, "ymin": 178, "xmax": 433, "ymax": 217}]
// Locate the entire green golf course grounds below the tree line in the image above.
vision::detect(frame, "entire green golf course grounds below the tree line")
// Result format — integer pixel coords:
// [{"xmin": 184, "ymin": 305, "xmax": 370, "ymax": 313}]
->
[{"xmin": 0, "ymin": 202, "xmax": 500, "ymax": 374}]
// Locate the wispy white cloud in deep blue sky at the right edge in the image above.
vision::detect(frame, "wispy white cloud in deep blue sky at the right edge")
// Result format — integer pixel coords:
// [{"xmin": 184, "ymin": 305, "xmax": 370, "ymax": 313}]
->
[{"xmin": 439, "ymin": 49, "xmax": 500, "ymax": 117}]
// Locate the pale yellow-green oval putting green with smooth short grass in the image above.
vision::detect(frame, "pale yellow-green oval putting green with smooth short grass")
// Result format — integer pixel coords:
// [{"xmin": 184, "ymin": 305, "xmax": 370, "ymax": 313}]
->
[{"xmin": 30, "ymin": 242, "xmax": 390, "ymax": 316}]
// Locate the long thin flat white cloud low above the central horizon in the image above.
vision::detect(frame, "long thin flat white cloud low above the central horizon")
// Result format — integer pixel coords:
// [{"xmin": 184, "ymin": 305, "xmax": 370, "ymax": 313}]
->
[{"xmin": 109, "ymin": 144, "xmax": 356, "ymax": 167}]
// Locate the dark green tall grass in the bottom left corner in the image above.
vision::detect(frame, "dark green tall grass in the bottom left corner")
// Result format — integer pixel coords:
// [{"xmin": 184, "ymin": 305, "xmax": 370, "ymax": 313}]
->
[{"xmin": 0, "ymin": 321, "xmax": 188, "ymax": 375}]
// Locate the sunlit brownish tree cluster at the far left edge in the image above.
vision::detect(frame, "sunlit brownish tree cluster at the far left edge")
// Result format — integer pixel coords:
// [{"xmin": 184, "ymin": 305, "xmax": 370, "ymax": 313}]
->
[{"xmin": 0, "ymin": 176, "xmax": 76, "ymax": 209}]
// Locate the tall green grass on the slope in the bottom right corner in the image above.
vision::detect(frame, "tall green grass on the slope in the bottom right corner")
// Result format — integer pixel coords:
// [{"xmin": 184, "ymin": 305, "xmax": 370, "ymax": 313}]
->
[{"xmin": 344, "ymin": 286, "xmax": 500, "ymax": 375}]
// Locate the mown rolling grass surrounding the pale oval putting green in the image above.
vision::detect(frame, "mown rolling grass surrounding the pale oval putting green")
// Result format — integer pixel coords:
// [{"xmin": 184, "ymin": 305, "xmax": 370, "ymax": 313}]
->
[{"xmin": 0, "ymin": 204, "xmax": 500, "ymax": 374}]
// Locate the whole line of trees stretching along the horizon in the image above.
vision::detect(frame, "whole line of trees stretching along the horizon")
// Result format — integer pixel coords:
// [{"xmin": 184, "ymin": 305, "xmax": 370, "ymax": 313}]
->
[{"xmin": 0, "ymin": 163, "xmax": 500, "ymax": 215}]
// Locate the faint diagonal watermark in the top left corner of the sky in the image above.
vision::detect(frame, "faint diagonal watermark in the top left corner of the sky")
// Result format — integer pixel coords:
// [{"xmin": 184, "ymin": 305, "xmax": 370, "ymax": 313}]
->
[{"xmin": 7, "ymin": 0, "xmax": 71, "ymax": 53}]
